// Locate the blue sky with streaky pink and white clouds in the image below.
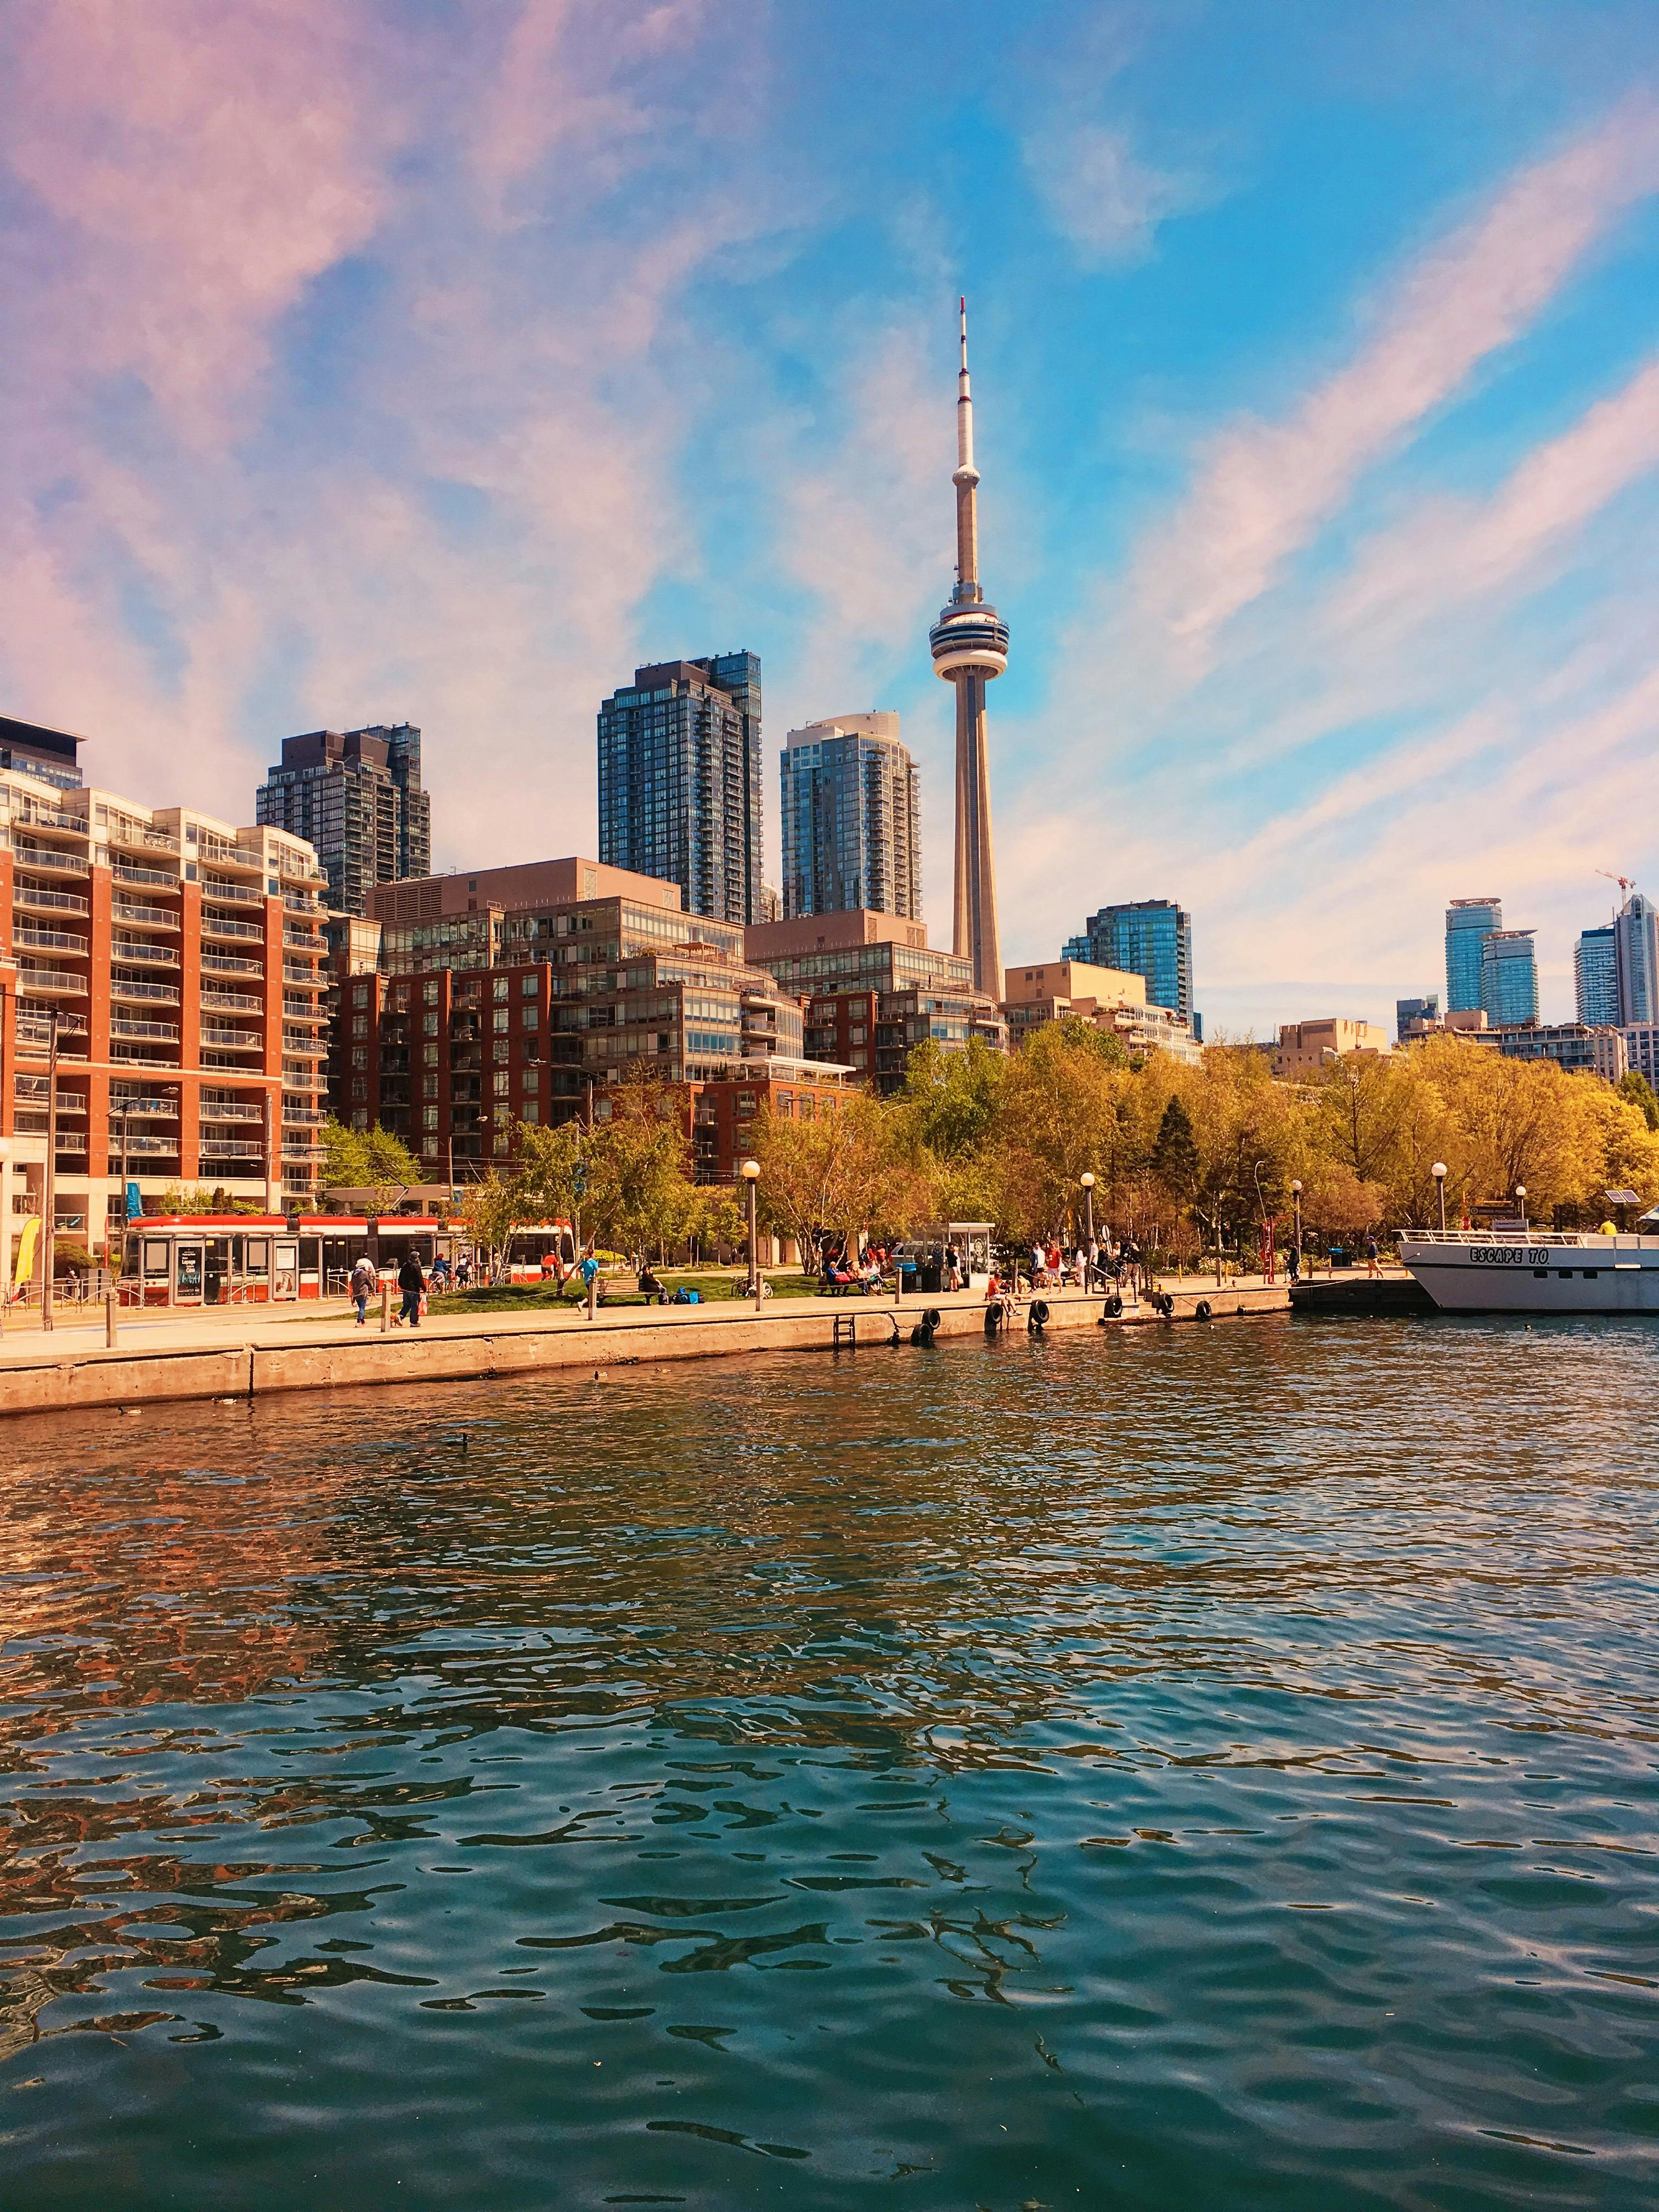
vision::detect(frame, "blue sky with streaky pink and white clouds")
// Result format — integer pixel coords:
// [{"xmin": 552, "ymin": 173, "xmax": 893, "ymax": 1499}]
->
[{"xmin": 0, "ymin": 0, "xmax": 1659, "ymax": 1035}]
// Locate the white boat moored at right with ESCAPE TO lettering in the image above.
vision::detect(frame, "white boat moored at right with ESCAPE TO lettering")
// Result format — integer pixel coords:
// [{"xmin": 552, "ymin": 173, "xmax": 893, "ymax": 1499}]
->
[{"xmin": 1400, "ymin": 1223, "xmax": 1659, "ymax": 1314}]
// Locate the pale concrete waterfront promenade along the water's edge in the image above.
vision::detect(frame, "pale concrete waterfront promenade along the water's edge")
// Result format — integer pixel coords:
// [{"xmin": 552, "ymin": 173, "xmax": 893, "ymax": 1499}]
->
[{"xmin": 0, "ymin": 1276, "xmax": 1290, "ymax": 1413}]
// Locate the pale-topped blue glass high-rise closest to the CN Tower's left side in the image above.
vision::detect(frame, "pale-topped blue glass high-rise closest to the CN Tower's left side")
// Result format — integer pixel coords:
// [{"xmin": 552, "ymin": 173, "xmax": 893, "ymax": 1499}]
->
[{"xmin": 778, "ymin": 714, "xmax": 922, "ymax": 922}]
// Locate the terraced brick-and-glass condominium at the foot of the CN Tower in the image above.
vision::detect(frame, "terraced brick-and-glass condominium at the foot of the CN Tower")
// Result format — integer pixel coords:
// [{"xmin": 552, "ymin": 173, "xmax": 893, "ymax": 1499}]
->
[{"xmin": 743, "ymin": 911, "xmax": 1009, "ymax": 1093}]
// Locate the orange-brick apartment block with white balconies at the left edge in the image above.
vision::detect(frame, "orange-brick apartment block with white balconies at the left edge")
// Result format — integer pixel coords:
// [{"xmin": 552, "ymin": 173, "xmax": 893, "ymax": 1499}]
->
[{"xmin": 0, "ymin": 725, "xmax": 325, "ymax": 1263}]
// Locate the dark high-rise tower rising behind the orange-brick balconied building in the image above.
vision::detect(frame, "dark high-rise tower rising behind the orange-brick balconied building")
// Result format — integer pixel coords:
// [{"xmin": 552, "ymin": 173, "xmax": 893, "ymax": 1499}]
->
[{"xmin": 255, "ymin": 721, "xmax": 431, "ymax": 916}]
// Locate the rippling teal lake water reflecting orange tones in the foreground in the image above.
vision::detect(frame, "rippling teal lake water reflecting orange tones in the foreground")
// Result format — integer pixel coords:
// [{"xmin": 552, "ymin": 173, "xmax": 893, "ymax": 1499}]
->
[{"xmin": 0, "ymin": 1321, "xmax": 1659, "ymax": 2212}]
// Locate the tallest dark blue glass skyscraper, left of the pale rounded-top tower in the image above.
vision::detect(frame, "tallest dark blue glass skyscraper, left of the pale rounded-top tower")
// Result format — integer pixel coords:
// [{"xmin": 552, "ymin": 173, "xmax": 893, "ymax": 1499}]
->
[{"xmin": 600, "ymin": 652, "xmax": 761, "ymax": 922}]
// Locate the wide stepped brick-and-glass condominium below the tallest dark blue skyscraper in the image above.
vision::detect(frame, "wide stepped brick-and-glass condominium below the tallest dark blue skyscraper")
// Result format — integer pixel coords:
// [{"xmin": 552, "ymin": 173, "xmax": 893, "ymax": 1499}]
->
[{"xmin": 349, "ymin": 860, "xmax": 827, "ymax": 1175}]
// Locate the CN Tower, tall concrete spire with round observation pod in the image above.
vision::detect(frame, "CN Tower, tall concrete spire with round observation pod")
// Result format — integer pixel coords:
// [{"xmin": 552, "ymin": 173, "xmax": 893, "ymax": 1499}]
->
[{"xmin": 927, "ymin": 301, "xmax": 1009, "ymax": 1000}]
